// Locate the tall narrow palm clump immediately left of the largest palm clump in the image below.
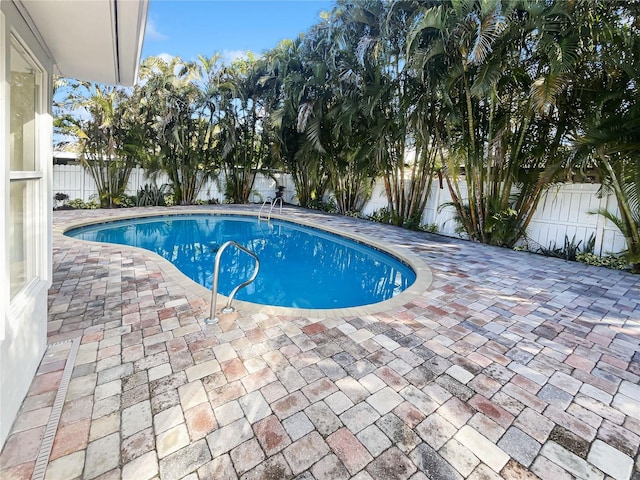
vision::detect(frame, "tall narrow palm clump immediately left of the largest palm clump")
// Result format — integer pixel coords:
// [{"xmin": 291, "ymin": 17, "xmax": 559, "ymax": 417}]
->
[{"xmin": 348, "ymin": 1, "xmax": 441, "ymax": 228}]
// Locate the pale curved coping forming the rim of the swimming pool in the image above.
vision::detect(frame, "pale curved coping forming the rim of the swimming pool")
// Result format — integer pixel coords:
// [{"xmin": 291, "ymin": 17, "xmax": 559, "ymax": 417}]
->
[{"xmin": 52, "ymin": 206, "xmax": 433, "ymax": 318}]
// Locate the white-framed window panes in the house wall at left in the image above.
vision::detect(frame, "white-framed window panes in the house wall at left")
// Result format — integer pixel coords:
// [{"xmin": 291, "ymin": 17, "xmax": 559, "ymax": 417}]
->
[{"xmin": 9, "ymin": 38, "xmax": 42, "ymax": 299}]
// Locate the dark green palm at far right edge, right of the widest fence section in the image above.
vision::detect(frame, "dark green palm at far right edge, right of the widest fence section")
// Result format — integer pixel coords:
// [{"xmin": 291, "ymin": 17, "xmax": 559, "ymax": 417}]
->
[{"xmin": 573, "ymin": 3, "xmax": 640, "ymax": 273}]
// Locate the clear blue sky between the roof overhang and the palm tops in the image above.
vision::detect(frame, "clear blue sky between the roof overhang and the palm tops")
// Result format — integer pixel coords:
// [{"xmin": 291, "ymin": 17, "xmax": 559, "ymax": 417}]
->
[{"xmin": 142, "ymin": 0, "xmax": 335, "ymax": 60}]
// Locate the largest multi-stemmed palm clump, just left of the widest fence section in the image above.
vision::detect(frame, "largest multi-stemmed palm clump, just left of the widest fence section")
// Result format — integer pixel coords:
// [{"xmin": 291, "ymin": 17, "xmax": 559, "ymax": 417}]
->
[{"xmin": 408, "ymin": 0, "xmax": 575, "ymax": 246}]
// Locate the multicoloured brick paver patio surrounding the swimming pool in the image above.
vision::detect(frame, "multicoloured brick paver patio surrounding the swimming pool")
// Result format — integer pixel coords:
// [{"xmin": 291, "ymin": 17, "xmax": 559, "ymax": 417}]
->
[{"xmin": 0, "ymin": 206, "xmax": 640, "ymax": 480}]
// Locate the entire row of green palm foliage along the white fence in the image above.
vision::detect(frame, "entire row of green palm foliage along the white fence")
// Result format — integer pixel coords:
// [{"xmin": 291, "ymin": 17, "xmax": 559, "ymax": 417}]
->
[{"xmin": 55, "ymin": 0, "xmax": 640, "ymax": 271}]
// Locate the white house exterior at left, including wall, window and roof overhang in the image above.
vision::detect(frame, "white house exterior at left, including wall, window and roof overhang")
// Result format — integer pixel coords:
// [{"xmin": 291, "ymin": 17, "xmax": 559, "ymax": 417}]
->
[{"xmin": 0, "ymin": 0, "xmax": 149, "ymax": 447}]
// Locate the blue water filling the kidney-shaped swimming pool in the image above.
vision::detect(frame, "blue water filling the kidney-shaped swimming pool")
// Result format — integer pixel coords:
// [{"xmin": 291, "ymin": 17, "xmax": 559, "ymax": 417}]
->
[{"xmin": 67, "ymin": 215, "xmax": 416, "ymax": 308}]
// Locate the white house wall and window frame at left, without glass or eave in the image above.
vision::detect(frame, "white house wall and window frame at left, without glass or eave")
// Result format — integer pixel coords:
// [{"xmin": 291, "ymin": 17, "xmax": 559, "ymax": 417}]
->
[{"xmin": 0, "ymin": 0, "xmax": 53, "ymax": 447}]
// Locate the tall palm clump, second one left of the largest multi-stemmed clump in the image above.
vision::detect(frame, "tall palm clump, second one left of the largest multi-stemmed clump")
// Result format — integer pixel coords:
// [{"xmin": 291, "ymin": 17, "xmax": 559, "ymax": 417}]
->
[{"xmin": 296, "ymin": 4, "xmax": 376, "ymax": 213}]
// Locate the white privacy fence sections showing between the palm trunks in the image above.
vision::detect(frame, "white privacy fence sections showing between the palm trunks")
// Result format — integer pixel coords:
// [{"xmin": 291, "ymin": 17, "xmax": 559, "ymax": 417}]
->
[{"xmin": 53, "ymin": 165, "xmax": 626, "ymax": 254}]
